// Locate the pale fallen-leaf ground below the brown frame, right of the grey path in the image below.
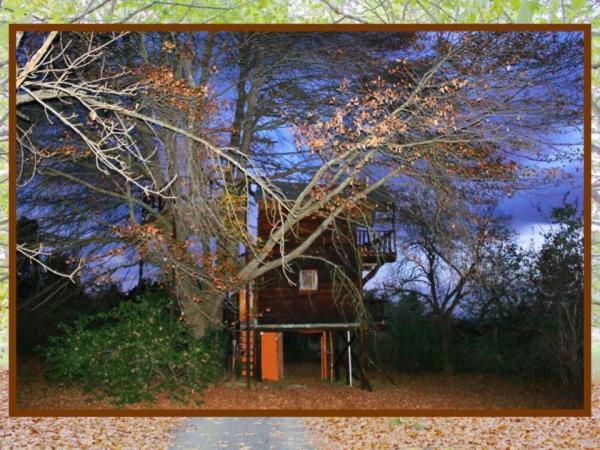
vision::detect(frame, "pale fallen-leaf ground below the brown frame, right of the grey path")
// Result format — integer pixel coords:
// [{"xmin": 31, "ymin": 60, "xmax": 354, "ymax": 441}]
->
[{"xmin": 304, "ymin": 384, "xmax": 600, "ymax": 450}]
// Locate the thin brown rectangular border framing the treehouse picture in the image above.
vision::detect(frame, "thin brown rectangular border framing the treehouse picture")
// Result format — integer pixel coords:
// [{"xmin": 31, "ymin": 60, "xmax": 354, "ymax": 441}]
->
[{"xmin": 8, "ymin": 24, "xmax": 592, "ymax": 417}]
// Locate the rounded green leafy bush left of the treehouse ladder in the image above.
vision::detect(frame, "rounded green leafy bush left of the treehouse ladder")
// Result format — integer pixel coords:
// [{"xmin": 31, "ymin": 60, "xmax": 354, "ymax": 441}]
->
[{"xmin": 44, "ymin": 293, "xmax": 227, "ymax": 405}]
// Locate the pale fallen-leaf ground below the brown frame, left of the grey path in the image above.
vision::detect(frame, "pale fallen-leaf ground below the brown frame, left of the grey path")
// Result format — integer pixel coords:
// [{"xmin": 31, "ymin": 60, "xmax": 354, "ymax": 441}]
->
[{"xmin": 0, "ymin": 370, "xmax": 181, "ymax": 450}]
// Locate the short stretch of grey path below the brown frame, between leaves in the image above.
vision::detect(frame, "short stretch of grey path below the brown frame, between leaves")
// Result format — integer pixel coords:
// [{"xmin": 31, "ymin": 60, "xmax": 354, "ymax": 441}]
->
[{"xmin": 171, "ymin": 417, "xmax": 314, "ymax": 450}]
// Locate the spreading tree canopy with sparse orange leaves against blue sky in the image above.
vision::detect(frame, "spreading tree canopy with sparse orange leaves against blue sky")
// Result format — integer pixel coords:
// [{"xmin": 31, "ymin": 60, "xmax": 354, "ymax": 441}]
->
[{"xmin": 17, "ymin": 32, "xmax": 583, "ymax": 333}]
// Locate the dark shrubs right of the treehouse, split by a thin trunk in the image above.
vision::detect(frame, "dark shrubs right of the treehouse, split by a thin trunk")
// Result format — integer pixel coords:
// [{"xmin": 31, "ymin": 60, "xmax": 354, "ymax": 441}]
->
[{"xmin": 371, "ymin": 204, "xmax": 583, "ymax": 387}]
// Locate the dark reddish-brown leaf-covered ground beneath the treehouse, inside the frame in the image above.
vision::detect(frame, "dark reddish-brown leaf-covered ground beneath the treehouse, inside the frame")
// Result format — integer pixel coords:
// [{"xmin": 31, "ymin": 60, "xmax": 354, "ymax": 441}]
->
[{"xmin": 17, "ymin": 364, "xmax": 580, "ymax": 410}]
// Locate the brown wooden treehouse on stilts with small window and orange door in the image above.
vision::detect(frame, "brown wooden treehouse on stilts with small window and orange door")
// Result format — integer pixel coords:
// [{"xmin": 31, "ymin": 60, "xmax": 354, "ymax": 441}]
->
[{"xmin": 234, "ymin": 184, "xmax": 396, "ymax": 388}]
